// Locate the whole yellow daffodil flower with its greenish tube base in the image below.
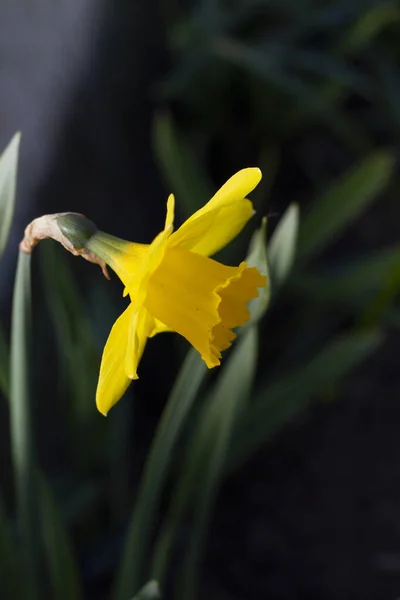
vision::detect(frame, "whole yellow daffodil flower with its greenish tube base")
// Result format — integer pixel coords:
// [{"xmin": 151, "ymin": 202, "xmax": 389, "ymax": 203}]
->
[{"xmin": 86, "ymin": 168, "xmax": 266, "ymax": 415}]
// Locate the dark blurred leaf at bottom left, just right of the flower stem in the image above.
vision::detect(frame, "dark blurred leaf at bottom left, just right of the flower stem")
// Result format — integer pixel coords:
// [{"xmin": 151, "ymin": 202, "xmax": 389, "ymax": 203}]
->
[{"xmin": 38, "ymin": 474, "xmax": 83, "ymax": 600}]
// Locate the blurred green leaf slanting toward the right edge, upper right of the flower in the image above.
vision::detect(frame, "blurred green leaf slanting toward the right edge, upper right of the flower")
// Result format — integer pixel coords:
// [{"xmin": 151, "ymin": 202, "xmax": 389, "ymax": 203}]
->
[{"xmin": 298, "ymin": 151, "xmax": 394, "ymax": 260}]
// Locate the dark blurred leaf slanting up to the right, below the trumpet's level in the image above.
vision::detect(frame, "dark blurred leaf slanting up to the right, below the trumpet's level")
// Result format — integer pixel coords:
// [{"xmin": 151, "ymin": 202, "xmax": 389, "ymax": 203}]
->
[{"xmin": 229, "ymin": 332, "xmax": 382, "ymax": 469}]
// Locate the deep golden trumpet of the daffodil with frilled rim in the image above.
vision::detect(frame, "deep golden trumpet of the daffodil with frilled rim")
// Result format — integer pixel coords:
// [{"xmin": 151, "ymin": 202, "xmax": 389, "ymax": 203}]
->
[{"xmin": 145, "ymin": 248, "xmax": 265, "ymax": 368}]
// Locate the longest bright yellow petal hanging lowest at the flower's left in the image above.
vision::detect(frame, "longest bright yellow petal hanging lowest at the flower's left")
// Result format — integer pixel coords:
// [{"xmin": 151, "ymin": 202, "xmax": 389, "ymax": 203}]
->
[{"xmin": 96, "ymin": 304, "xmax": 132, "ymax": 415}]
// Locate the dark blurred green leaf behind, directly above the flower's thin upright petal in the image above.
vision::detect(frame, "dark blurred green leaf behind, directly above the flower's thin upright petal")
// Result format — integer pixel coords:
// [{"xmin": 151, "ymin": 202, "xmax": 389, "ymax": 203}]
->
[{"xmin": 153, "ymin": 113, "xmax": 212, "ymax": 217}]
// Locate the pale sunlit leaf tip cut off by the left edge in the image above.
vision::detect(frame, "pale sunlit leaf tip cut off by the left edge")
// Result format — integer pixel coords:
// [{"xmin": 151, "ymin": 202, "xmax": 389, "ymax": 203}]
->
[{"xmin": 0, "ymin": 133, "xmax": 21, "ymax": 259}]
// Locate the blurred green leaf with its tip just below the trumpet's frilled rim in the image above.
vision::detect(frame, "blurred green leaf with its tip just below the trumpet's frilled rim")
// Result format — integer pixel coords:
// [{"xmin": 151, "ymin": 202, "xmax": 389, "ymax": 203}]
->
[{"xmin": 175, "ymin": 327, "xmax": 257, "ymax": 600}]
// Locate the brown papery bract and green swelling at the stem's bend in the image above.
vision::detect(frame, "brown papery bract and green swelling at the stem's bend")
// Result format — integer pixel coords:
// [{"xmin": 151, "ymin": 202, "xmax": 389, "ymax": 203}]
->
[{"xmin": 19, "ymin": 212, "xmax": 110, "ymax": 279}]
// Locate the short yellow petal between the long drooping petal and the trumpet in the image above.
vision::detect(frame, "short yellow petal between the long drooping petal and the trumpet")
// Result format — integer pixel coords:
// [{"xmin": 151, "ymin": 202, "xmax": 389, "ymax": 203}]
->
[{"xmin": 125, "ymin": 307, "xmax": 154, "ymax": 379}]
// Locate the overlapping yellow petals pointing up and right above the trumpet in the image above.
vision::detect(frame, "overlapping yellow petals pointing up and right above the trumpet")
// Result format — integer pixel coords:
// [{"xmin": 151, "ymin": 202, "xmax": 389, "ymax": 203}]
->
[{"xmin": 169, "ymin": 168, "xmax": 261, "ymax": 256}]
